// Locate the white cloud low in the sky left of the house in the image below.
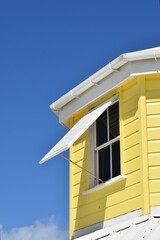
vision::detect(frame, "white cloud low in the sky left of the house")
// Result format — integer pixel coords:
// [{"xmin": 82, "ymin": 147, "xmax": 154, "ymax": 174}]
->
[{"xmin": 1, "ymin": 217, "xmax": 68, "ymax": 240}]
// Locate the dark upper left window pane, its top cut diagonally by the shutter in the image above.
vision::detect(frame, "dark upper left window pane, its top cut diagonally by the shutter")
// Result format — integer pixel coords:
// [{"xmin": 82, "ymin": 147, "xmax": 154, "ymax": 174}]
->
[{"xmin": 96, "ymin": 111, "xmax": 108, "ymax": 147}]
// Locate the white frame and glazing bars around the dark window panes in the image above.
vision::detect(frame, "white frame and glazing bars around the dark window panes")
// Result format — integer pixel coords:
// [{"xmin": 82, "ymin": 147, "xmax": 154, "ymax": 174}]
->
[{"xmin": 89, "ymin": 95, "xmax": 121, "ymax": 188}]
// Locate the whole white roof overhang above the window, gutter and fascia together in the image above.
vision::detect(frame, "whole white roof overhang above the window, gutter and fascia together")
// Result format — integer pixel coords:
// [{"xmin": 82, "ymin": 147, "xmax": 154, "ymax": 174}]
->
[{"xmin": 50, "ymin": 47, "xmax": 160, "ymax": 127}]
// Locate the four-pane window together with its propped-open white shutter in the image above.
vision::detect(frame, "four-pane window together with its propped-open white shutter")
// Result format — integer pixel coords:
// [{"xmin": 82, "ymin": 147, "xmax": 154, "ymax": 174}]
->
[{"xmin": 40, "ymin": 95, "xmax": 120, "ymax": 188}]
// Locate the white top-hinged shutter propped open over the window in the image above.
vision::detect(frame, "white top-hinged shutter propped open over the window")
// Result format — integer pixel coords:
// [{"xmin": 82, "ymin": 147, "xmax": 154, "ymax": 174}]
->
[{"xmin": 39, "ymin": 95, "xmax": 118, "ymax": 164}]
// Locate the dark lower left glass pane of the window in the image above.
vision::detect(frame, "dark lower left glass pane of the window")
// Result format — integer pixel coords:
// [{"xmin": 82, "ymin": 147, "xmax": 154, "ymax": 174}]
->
[{"xmin": 99, "ymin": 147, "xmax": 111, "ymax": 183}]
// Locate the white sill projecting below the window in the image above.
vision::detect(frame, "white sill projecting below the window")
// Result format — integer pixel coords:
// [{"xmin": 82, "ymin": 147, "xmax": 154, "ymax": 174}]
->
[{"xmin": 82, "ymin": 175, "xmax": 127, "ymax": 195}]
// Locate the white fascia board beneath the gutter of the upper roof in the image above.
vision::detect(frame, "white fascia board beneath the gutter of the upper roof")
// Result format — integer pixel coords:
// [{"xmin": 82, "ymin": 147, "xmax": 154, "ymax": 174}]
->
[{"xmin": 59, "ymin": 59, "xmax": 160, "ymax": 127}]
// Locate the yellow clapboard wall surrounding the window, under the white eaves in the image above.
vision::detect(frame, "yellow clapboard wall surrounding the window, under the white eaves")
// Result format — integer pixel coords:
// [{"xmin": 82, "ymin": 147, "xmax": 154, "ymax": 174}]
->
[{"xmin": 70, "ymin": 75, "xmax": 160, "ymax": 238}]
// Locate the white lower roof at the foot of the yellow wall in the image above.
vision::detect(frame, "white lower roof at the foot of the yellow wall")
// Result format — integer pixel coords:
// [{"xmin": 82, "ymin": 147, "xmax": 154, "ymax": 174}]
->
[{"xmin": 75, "ymin": 215, "xmax": 160, "ymax": 240}]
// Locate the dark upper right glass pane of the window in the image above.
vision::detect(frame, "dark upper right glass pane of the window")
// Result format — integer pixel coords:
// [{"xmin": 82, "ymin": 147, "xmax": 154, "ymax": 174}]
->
[{"xmin": 109, "ymin": 102, "xmax": 119, "ymax": 140}]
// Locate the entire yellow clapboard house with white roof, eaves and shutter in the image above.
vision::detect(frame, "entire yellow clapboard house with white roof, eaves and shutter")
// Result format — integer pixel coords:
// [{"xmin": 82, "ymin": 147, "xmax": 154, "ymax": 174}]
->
[{"xmin": 40, "ymin": 47, "xmax": 160, "ymax": 240}]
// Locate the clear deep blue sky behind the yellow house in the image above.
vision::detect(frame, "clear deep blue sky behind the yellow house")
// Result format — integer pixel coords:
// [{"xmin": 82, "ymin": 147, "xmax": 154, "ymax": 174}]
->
[{"xmin": 0, "ymin": 0, "xmax": 160, "ymax": 240}]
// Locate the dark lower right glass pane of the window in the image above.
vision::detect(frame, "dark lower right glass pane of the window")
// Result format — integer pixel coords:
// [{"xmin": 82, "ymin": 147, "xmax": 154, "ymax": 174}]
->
[{"xmin": 112, "ymin": 141, "xmax": 120, "ymax": 177}]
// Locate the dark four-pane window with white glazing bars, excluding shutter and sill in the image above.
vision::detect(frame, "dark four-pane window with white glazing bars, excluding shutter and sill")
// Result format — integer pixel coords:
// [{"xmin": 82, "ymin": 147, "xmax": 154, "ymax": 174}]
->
[{"xmin": 91, "ymin": 101, "xmax": 120, "ymax": 187}]
